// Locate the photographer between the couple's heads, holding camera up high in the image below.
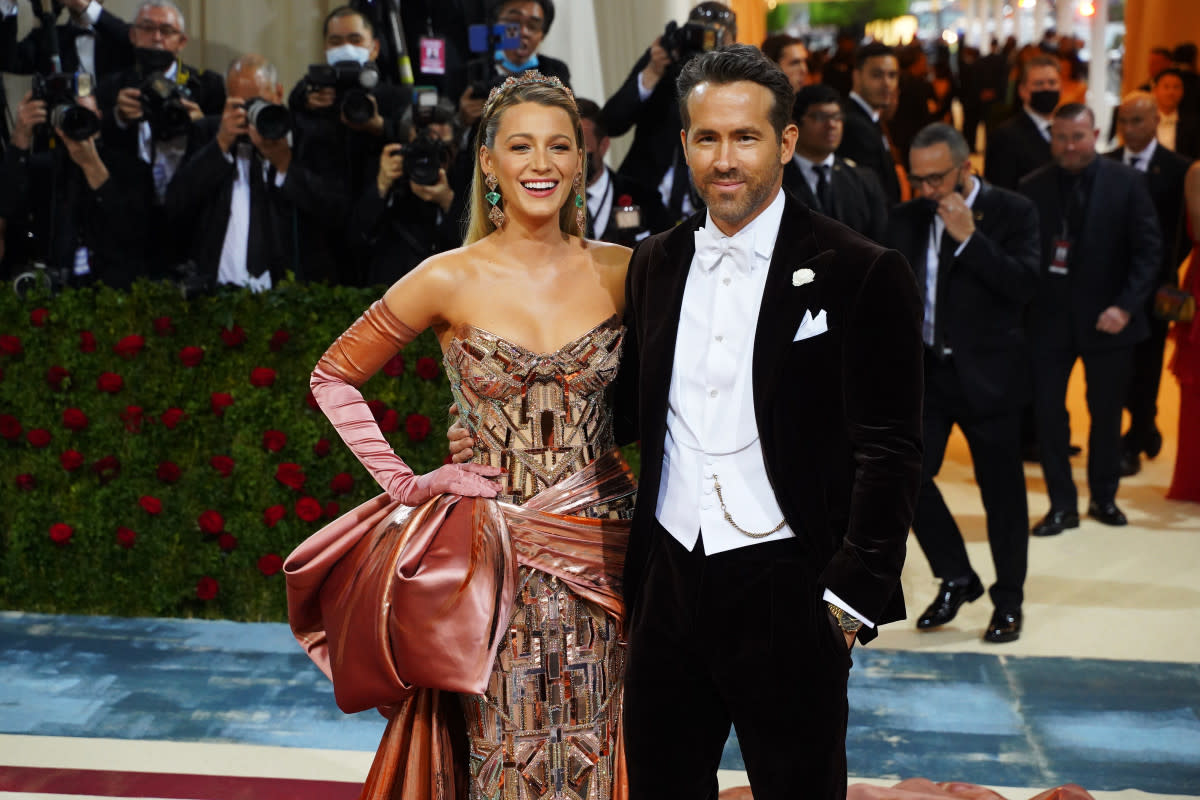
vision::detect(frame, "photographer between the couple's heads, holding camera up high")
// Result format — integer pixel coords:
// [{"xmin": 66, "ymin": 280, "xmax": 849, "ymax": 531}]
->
[{"xmin": 604, "ymin": 2, "xmax": 737, "ymax": 221}]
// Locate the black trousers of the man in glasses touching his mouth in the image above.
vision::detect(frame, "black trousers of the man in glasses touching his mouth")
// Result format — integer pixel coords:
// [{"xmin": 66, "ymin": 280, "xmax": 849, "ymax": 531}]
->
[{"xmin": 912, "ymin": 351, "xmax": 1030, "ymax": 610}]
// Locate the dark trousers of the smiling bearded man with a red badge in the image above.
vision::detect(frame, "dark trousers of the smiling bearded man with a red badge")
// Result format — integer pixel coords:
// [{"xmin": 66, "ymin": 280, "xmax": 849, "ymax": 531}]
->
[{"xmin": 1033, "ymin": 343, "xmax": 1133, "ymax": 511}]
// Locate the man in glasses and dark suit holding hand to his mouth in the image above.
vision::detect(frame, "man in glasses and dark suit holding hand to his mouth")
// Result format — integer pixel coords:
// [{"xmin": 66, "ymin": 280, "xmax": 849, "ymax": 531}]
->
[{"xmin": 886, "ymin": 122, "xmax": 1042, "ymax": 643}]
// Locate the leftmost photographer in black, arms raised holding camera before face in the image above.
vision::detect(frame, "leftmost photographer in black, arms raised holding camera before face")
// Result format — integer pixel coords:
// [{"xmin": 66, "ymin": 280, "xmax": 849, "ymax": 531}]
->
[{"xmin": 0, "ymin": 91, "xmax": 148, "ymax": 288}]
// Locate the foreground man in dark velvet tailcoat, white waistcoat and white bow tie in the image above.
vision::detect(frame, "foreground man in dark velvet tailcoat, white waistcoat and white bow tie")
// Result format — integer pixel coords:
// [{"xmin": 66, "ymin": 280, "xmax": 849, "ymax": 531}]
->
[{"xmin": 614, "ymin": 44, "xmax": 923, "ymax": 800}]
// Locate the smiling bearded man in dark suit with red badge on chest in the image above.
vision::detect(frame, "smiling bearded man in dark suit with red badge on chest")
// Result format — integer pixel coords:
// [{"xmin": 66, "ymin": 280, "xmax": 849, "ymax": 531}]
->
[{"xmin": 1021, "ymin": 103, "xmax": 1162, "ymax": 536}]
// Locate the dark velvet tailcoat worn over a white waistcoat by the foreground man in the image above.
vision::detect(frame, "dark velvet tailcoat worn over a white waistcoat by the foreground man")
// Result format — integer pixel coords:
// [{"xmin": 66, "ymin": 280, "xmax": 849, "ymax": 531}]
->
[{"xmin": 614, "ymin": 190, "xmax": 923, "ymax": 640}]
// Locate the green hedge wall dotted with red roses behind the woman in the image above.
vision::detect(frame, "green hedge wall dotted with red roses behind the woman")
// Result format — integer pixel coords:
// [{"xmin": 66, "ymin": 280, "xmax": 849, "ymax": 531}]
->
[{"xmin": 0, "ymin": 283, "xmax": 450, "ymax": 620}]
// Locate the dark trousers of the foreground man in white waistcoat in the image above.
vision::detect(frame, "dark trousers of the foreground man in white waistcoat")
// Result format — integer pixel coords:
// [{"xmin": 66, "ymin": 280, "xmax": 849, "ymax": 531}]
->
[{"xmin": 624, "ymin": 522, "xmax": 851, "ymax": 800}]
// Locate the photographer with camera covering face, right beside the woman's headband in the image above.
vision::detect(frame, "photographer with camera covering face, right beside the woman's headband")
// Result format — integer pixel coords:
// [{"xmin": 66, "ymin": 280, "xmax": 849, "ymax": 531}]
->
[{"xmin": 350, "ymin": 95, "xmax": 473, "ymax": 285}]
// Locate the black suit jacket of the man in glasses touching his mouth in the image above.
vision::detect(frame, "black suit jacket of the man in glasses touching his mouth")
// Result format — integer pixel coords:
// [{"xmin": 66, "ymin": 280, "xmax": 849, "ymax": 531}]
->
[{"xmin": 887, "ymin": 182, "xmax": 1042, "ymax": 415}]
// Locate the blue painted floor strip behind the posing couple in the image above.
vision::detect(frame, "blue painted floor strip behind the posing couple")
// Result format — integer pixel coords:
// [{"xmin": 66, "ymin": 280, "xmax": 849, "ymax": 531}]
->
[{"xmin": 0, "ymin": 613, "xmax": 1200, "ymax": 795}]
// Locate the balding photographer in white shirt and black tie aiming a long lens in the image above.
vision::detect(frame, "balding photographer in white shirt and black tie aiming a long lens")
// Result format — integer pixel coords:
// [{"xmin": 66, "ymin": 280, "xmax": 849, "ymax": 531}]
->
[{"xmin": 167, "ymin": 54, "xmax": 344, "ymax": 290}]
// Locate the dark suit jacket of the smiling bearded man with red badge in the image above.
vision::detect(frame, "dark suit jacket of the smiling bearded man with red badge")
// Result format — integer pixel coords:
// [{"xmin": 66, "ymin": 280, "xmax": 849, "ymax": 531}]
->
[{"xmin": 1020, "ymin": 158, "xmax": 1163, "ymax": 353}]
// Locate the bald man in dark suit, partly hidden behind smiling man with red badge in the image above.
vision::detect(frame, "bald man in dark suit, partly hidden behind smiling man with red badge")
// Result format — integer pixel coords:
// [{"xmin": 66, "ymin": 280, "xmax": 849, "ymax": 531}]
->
[{"xmin": 1108, "ymin": 91, "xmax": 1190, "ymax": 476}]
